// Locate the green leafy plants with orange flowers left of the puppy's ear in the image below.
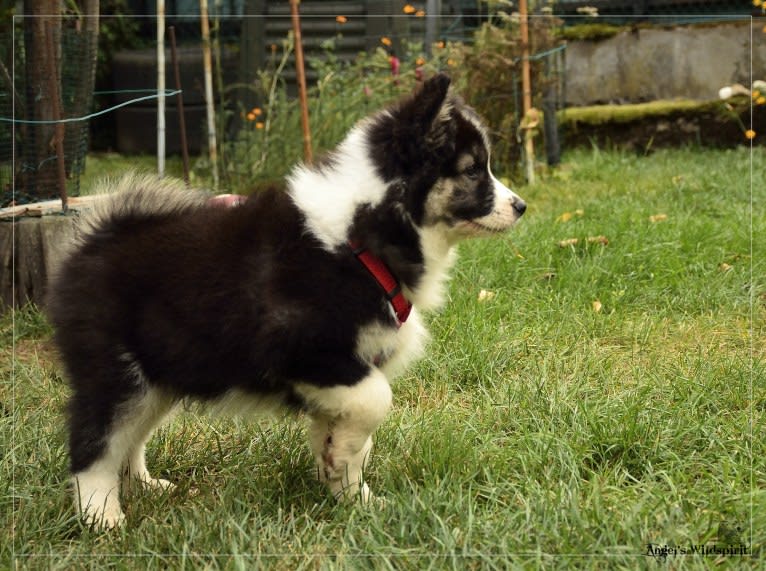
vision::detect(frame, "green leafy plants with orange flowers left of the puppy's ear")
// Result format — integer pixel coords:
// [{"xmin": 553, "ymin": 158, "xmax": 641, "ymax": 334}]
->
[{"xmin": 214, "ymin": 36, "xmax": 462, "ymax": 190}]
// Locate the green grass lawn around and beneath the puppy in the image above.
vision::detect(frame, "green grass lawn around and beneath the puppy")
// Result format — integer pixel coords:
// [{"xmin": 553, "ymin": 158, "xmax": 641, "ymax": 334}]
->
[{"xmin": 0, "ymin": 148, "xmax": 766, "ymax": 569}]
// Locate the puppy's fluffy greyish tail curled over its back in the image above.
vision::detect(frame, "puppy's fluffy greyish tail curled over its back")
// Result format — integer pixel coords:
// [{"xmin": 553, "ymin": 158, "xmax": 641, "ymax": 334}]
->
[{"xmin": 79, "ymin": 172, "xmax": 210, "ymax": 237}]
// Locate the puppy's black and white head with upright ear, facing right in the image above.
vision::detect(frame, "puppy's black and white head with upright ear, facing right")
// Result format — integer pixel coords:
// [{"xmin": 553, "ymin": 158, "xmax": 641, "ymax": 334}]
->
[{"xmin": 368, "ymin": 74, "xmax": 526, "ymax": 240}]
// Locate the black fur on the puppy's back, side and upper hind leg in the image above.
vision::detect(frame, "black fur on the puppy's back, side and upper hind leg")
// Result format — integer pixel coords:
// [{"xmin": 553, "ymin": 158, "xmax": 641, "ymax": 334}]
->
[{"xmin": 48, "ymin": 185, "xmax": 402, "ymax": 472}]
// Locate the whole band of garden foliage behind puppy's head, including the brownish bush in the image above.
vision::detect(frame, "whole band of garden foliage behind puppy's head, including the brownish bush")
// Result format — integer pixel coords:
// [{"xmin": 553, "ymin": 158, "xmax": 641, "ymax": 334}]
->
[{"xmin": 213, "ymin": 11, "xmax": 560, "ymax": 189}]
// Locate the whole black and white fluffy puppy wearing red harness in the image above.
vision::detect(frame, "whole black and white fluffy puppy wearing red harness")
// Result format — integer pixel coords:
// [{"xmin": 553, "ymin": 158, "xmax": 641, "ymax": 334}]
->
[{"xmin": 48, "ymin": 75, "xmax": 526, "ymax": 527}]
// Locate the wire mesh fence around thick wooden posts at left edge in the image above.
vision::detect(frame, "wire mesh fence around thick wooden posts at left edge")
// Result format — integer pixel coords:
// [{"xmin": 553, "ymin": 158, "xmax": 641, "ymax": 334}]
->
[{"xmin": 0, "ymin": 26, "xmax": 97, "ymax": 207}]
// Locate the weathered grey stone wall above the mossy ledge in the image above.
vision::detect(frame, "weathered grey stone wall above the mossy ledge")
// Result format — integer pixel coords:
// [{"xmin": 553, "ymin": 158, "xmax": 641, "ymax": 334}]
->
[{"xmin": 566, "ymin": 20, "xmax": 766, "ymax": 106}]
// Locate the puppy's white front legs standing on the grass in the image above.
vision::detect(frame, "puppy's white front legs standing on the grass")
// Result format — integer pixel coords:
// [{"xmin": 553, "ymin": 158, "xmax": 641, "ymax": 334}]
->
[{"xmin": 300, "ymin": 369, "xmax": 391, "ymax": 502}]
